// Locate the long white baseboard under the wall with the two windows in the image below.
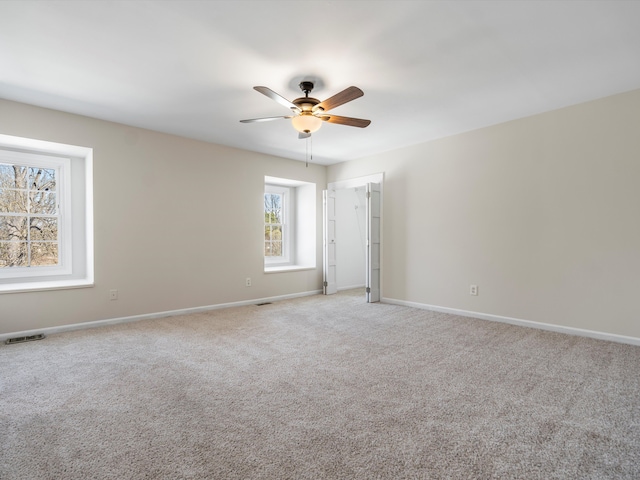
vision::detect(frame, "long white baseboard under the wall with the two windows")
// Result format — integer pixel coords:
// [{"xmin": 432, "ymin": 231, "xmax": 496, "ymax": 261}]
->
[{"xmin": 0, "ymin": 290, "xmax": 322, "ymax": 342}]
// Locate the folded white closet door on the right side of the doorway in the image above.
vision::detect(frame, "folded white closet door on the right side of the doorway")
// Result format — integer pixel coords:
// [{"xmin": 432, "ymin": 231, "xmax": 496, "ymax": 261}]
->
[{"xmin": 366, "ymin": 183, "xmax": 381, "ymax": 303}]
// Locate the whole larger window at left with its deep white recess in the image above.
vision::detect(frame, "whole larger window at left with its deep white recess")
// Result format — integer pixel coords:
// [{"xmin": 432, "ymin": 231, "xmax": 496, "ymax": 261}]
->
[{"xmin": 0, "ymin": 135, "xmax": 93, "ymax": 293}]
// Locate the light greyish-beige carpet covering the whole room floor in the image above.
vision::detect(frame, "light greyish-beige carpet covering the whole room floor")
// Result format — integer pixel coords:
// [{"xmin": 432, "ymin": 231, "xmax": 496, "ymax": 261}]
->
[{"xmin": 0, "ymin": 292, "xmax": 640, "ymax": 480}]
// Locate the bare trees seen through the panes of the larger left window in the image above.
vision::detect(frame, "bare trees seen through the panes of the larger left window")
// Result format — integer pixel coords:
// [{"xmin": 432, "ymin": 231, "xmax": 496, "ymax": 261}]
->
[{"xmin": 0, "ymin": 163, "xmax": 59, "ymax": 268}]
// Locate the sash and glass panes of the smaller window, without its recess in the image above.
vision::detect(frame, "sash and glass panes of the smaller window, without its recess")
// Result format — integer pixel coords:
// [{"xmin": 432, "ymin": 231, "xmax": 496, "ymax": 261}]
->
[{"xmin": 264, "ymin": 185, "xmax": 294, "ymax": 265}]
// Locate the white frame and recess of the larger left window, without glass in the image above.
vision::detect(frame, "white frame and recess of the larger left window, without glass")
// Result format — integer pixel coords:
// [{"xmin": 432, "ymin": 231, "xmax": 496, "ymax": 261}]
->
[{"xmin": 0, "ymin": 134, "xmax": 94, "ymax": 294}]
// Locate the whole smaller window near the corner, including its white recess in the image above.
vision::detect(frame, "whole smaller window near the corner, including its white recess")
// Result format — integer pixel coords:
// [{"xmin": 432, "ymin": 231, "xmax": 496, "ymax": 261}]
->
[{"xmin": 263, "ymin": 177, "xmax": 317, "ymax": 273}]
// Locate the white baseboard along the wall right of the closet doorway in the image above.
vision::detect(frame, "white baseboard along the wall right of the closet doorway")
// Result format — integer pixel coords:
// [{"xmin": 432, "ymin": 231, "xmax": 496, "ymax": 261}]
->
[{"xmin": 381, "ymin": 298, "xmax": 640, "ymax": 346}]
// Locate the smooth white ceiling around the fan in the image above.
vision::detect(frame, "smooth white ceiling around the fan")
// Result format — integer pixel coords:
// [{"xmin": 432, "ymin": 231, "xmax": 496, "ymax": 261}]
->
[{"xmin": 0, "ymin": 0, "xmax": 640, "ymax": 165}]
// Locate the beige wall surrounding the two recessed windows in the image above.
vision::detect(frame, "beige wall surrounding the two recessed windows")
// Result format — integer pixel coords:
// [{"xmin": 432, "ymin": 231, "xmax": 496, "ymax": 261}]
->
[{"xmin": 0, "ymin": 100, "xmax": 326, "ymax": 334}]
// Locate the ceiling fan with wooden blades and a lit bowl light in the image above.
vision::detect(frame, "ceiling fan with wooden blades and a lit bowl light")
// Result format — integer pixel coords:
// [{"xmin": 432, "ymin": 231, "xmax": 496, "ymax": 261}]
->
[{"xmin": 240, "ymin": 81, "xmax": 371, "ymax": 138}]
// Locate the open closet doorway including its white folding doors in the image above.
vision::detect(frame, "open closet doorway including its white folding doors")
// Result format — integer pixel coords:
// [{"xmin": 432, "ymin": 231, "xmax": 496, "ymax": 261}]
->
[{"xmin": 323, "ymin": 173, "xmax": 383, "ymax": 302}]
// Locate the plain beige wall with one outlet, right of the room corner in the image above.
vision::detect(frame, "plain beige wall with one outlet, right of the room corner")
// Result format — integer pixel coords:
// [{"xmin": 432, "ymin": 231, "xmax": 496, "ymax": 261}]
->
[{"xmin": 328, "ymin": 90, "xmax": 640, "ymax": 338}]
